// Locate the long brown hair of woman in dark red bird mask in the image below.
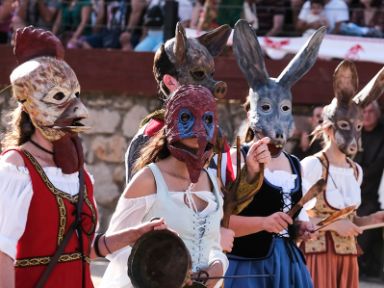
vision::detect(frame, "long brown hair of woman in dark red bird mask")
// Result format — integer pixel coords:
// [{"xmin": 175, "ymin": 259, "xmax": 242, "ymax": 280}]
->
[{"xmin": 133, "ymin": 127, "xmax": 171, "ymax": 173}]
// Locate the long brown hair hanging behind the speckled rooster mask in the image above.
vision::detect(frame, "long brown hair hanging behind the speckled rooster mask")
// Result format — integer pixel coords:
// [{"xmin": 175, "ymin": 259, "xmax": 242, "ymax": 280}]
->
[{"xmin": 1, "ymin": 106, "xmax": 35, "ymax": 150}]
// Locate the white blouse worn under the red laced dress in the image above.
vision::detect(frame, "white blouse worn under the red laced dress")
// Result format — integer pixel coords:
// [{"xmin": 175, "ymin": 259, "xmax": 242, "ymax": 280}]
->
[{"xmin": 0, "ymin": 158, "xmax": 86, "ymax": 259}]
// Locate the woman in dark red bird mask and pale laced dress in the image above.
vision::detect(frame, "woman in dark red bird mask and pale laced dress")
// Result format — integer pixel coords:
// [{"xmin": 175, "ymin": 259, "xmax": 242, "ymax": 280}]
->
[{"xmin": 101, "ymin": 85, "xmax": 228, "ymax": 288}]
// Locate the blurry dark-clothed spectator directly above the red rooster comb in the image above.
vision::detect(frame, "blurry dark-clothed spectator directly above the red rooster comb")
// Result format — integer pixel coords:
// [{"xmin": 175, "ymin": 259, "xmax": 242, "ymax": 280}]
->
[{"xmin": 12, "ymin": 0, "xmax": 60, "ymax": 31}]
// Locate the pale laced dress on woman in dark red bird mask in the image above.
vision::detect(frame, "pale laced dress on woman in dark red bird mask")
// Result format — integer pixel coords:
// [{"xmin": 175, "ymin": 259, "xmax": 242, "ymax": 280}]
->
[{"xmin": 100, "ymin": 163, "xmax": 228, "ymax": 288}]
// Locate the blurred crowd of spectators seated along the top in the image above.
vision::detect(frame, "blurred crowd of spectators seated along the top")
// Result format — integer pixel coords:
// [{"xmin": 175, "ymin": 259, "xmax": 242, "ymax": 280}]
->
[{"xmin": 0, "ymin": 0, "xmax": 384, "ymax": 51}]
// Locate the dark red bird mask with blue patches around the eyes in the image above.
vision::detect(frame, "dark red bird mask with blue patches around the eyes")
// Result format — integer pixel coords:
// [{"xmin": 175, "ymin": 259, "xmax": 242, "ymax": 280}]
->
[{"xmin": 165, "ymin": 85, "xmax": 217, "ymax": 183}]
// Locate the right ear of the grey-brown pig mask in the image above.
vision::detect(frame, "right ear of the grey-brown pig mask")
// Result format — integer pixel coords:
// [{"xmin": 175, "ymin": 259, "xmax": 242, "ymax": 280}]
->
[{"xmin": 196, "ymin": 25, "xmax": 232, "ymax": 57}]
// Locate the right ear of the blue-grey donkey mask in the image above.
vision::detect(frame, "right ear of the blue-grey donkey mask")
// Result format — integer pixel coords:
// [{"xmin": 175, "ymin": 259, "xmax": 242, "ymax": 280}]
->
[{"xmin": 277, "ymin": 26, "xmax": 326, "ymax": 87}]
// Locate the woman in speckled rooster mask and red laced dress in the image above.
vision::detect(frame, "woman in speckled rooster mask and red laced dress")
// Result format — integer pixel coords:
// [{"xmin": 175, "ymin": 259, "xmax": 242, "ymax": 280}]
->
[{"xmin": 0, "ymin": 27, "xmax": 165, "ymax": 288}]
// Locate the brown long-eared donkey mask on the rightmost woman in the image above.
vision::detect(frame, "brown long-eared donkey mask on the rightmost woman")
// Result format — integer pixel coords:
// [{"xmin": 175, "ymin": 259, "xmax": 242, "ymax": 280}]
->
[{"xmin": 323, "ymin": 61, "xmax": 384, "ymax": 156}]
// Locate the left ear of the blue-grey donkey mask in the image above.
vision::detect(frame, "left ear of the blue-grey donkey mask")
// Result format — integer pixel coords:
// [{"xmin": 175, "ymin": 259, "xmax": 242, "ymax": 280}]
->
[{"xmin": 233, "ymin": 20, "xmax": 269, "ymax": 89}]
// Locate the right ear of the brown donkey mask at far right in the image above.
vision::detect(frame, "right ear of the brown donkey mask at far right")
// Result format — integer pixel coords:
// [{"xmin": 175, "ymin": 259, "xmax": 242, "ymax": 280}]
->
[{"xmin": 353, "ymin": 67, "xmax": 384, "ymax": 107}]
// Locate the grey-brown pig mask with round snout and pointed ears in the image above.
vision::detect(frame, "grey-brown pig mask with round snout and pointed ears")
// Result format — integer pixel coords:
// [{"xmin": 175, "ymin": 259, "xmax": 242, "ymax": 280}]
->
[{"xmin": 164, "ymin": 23, "xmax": 231, "ymax": 98}]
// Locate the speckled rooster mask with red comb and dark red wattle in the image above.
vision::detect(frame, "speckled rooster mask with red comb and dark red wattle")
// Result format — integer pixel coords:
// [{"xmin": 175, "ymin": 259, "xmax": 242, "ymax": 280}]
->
[{"xmin": 10, "ymin": 26, "xmax": 88, "ymax": 173}]
